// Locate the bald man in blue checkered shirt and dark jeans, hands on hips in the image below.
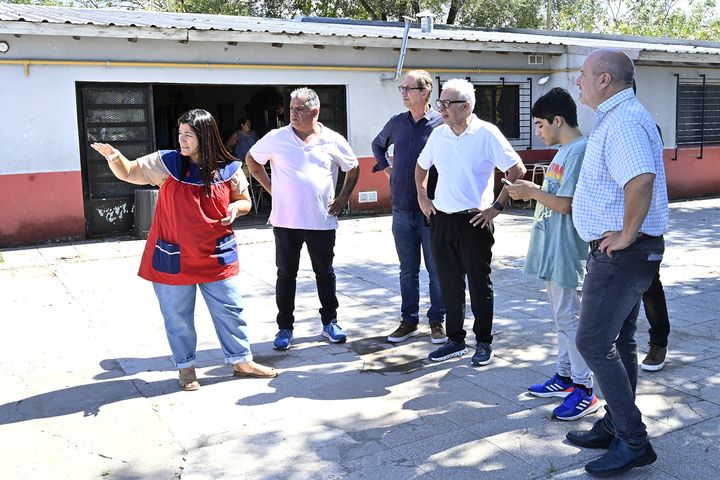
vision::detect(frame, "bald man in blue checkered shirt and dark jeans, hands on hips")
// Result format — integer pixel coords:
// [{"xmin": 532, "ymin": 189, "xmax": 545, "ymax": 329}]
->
[{"xmin": 567, "ymin": 49, "xmax": 668, "ymax": 476}]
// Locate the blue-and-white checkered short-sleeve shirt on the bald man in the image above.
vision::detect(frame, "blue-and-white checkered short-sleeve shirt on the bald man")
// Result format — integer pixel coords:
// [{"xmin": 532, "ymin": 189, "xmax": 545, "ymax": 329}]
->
[{"xmin": 572, "ymin": 88, "xmax": 668, "ymax": 242}]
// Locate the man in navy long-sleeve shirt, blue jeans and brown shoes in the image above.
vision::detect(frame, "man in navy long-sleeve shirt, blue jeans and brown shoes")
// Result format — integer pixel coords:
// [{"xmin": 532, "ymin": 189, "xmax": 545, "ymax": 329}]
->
[{"xmin": 372, "ymin": 70, "xmax": 447, "ymax": 343}]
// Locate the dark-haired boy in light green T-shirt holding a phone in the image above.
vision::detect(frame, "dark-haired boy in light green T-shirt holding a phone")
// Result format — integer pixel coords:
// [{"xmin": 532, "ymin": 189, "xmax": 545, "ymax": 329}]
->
[{"xmin": 505, "ymin": 88, "xmax": 600, "ymax": 420}]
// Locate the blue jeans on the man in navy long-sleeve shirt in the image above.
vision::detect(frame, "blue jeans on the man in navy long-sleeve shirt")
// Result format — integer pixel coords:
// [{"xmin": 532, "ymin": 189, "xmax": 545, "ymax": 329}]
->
[{"xmin": 392, "ymin": 209, "xmax": 445, "ymax": 325}]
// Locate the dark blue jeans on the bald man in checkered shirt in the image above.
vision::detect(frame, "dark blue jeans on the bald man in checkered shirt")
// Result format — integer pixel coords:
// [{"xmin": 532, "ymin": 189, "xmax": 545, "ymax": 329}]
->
[{"xmin": 575, "ymin": 236, "xmax": 665, "ymax": 445}]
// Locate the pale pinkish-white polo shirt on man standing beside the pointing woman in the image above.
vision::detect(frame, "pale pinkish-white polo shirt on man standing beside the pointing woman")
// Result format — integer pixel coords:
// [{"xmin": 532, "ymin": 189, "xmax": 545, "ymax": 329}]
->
[{"xmin": 250, "ymin": 125, "xmax": 358, "ymax": 230}]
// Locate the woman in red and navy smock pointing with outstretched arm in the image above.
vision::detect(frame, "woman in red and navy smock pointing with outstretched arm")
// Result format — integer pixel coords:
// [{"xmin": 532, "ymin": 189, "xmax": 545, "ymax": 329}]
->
[{"xmin": 92, "ymin": 109, "xmax": 277, "ymax": 391}]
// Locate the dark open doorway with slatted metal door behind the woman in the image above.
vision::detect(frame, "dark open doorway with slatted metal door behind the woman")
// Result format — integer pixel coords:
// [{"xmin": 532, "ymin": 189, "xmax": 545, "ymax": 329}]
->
[{"xmin": 77, "ymin": 83, "xmax": 347, "ymax": 237}]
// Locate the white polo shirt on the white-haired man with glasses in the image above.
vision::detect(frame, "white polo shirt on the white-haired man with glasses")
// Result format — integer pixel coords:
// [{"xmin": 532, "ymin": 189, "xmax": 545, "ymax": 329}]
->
[{"xmin": 417, "ymin": 114, "xmax": 520, "ymax": 213}]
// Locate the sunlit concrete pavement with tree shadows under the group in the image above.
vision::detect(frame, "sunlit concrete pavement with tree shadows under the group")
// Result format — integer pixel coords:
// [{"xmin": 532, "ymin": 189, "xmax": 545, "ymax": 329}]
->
[{"xmin": 0, "ymin": 199, "xmax": 720, "ymax": 480}]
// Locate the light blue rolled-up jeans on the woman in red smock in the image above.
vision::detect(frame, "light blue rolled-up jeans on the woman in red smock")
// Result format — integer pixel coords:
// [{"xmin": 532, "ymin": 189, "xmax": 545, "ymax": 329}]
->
[{"xmin": 153, "ymin": 276, "xmax": 253, "ymax": 368}]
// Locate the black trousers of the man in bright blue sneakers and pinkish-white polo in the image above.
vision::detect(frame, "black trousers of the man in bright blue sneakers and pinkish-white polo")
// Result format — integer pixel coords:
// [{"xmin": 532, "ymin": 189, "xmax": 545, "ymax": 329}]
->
[{"xmin": 273, "ymin": 227, "xmax": 338, "ymax": 330}]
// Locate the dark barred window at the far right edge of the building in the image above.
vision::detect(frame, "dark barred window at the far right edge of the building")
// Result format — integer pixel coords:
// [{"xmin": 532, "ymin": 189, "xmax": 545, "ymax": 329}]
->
[{"xmin": 675, "ymin": 75, "xmax": 720, "ymax": 159}]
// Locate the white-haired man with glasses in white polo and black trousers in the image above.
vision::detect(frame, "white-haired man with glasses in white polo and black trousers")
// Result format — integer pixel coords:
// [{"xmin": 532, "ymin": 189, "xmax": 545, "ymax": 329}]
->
[{"xmin": 415, "ymin": 79, "xmax": 526, "ymax": 365}]
